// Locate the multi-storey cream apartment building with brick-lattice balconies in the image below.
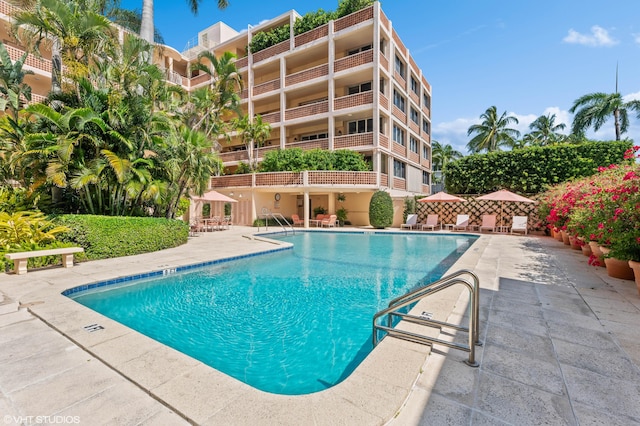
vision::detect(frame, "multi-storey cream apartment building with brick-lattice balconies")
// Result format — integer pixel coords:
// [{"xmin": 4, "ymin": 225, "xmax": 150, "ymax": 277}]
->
[{"xmin": 0, "ymin": 1, "xmax": 431, "ymax": 226}]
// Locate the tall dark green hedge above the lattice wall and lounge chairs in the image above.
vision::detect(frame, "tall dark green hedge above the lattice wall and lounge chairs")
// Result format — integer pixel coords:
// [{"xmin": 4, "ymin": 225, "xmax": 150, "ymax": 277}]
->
[{"xmin": 444, "ymin": 141, "xmax": 632, "ymax": 194}]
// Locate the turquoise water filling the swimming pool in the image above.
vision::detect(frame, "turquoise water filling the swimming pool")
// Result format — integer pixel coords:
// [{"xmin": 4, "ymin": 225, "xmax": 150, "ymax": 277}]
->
[{"xmin": 65, "ymin": 232, "xmax": 477, "ymax": 395}]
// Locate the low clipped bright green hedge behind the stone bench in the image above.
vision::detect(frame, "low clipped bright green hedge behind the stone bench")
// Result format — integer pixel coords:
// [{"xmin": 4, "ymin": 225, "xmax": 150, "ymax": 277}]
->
[{"xmin": 56, "ymin": 215, "xmax": 189, "ymax": 260}]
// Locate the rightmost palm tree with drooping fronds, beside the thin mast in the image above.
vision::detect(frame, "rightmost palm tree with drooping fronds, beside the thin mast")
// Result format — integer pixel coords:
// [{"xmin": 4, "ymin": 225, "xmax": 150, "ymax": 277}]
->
[{"xmin": 569, "ymin": 91, "xmax": 640, "ymax": 141}]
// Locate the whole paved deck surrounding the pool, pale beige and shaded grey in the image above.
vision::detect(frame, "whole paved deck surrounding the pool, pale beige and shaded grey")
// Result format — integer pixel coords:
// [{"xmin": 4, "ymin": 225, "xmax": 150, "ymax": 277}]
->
[{"xmin": 0, "ymin": 227, "xmax": 640, "ymax": 425}]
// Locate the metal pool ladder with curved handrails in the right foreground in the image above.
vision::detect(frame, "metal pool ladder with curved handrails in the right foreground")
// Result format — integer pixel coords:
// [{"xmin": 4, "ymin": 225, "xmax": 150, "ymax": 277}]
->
[{"xmin": 373, "ymin": 269, "xmax": 482, "ymax": 367}]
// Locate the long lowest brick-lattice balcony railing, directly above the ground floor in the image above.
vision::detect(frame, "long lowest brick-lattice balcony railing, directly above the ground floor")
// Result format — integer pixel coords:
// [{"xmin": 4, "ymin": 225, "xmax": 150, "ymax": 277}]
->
[{"xmin": 211, "ymin": 171, "xmax": 377, "ymax": 189}]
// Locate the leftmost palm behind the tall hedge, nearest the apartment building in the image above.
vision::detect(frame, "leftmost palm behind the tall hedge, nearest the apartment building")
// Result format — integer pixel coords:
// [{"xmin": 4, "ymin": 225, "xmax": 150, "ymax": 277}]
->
[{"xmin": 467, "ymin": 106, "xmax": 520, "ymax": 153}]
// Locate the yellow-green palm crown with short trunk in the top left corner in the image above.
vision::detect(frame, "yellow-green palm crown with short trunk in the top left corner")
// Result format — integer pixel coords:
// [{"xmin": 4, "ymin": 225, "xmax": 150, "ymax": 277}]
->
[{"xmin": 14, "ymin": 0, "xmax": 113, "ymax": 94}]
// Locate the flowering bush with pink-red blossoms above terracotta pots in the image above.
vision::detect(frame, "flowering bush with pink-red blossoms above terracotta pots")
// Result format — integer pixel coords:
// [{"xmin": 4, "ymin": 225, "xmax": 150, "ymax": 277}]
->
[{"xmin": 545, "ymin": 146, "xmax": 640, "ymax": 261}]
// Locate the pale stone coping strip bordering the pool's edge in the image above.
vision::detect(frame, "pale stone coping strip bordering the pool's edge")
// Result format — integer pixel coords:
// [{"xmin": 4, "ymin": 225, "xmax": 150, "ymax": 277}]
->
[{"xmin": 1, "ymin": 228, "xmax": 489, "ymax": 424}]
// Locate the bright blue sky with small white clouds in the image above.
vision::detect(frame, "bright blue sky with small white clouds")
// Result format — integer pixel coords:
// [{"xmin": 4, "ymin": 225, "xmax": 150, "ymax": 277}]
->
[{"xmin": 123, "ymin": 0, "xmax": 640, "ymax": 154}]
